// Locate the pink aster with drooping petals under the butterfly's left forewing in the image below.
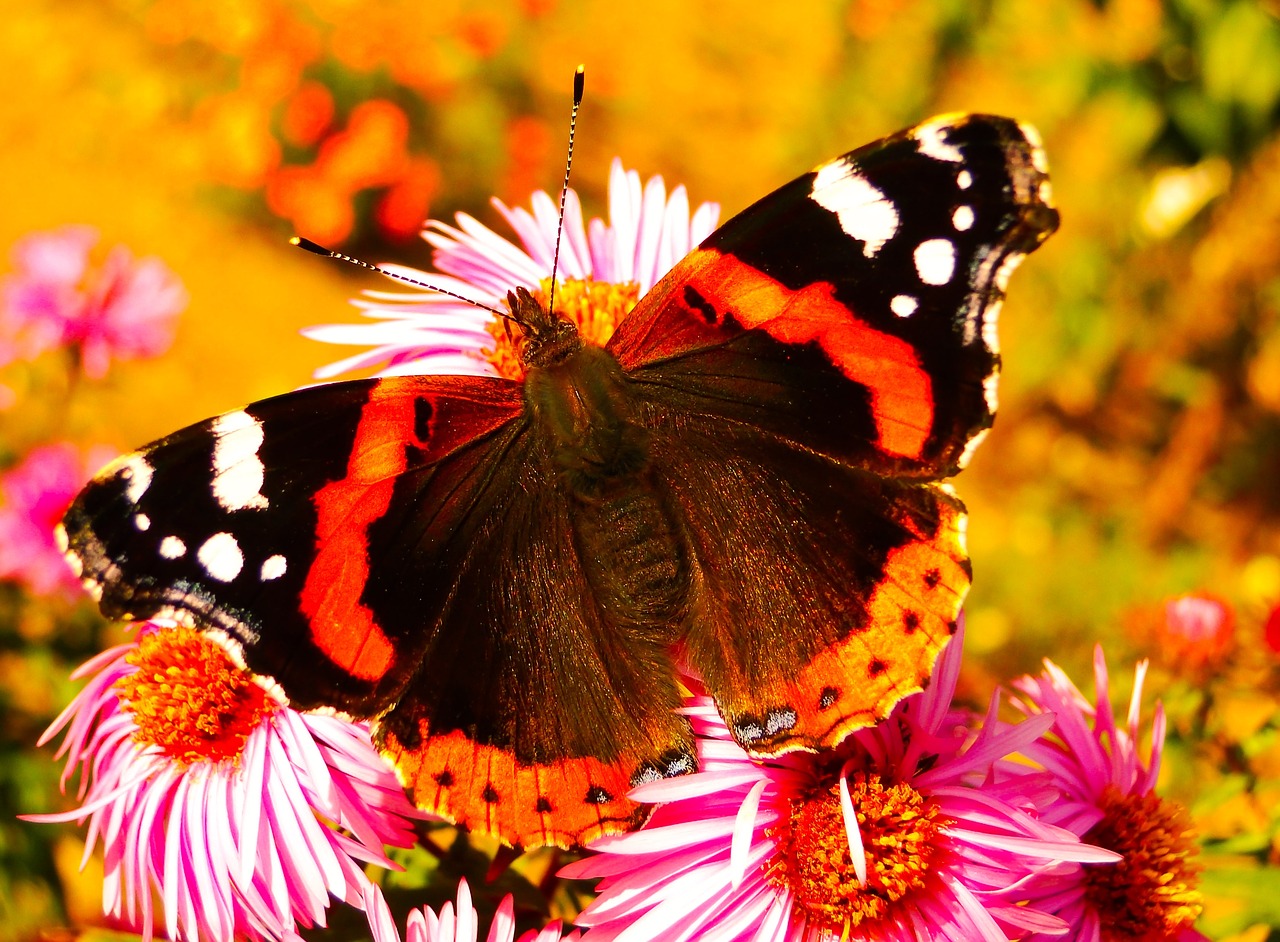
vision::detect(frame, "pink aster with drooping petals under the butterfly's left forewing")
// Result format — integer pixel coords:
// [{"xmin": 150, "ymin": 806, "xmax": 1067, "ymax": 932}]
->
[{"xmin": 29, "ymin": 622, "xmax": 421, "ymax": 942}]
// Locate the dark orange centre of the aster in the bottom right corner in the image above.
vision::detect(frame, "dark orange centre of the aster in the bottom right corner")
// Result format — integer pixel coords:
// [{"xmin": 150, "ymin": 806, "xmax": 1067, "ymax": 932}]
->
[{"xmin": 1084, "ymin": 786, "xmax": 1203, "ymax": 942}]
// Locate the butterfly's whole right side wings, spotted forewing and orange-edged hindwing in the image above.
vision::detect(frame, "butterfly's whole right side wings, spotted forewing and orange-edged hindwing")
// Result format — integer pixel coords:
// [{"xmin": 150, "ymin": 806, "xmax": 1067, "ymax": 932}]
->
[{"xmin": 609, "ymin": 115, "xmax": 1057, "ymax": 754}]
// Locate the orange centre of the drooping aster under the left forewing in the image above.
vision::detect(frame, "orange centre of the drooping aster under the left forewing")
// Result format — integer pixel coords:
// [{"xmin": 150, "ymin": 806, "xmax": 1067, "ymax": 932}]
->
[{"xmin": 115, "ymin": 627, "xmax": 279, "ymax": 763}]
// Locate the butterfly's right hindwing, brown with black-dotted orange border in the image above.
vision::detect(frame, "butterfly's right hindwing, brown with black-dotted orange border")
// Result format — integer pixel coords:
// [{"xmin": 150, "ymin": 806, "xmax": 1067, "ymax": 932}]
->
[{"xmin": 653, "ymin": 420, "xmax": 970, "ymax": 755}]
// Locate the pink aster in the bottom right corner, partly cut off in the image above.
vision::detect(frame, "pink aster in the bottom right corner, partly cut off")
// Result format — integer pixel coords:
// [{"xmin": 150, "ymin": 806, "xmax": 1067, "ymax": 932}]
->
[{"xmin": 1012, "ymin": 646, "xmax": 1204, "ymax": 942}]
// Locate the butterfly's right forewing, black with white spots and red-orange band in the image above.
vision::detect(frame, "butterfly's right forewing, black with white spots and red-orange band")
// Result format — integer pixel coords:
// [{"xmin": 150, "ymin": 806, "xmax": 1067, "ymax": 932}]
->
[{"xmin": 608, "ymin": 115, "xmax": 1057, "ymax": 479}]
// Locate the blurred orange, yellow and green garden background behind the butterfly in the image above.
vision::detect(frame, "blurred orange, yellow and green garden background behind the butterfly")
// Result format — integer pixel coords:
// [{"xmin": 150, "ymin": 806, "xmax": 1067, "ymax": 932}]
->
[{"xmin": 0, "ymin": 0, "xmax": 1280, "ymax": 942}]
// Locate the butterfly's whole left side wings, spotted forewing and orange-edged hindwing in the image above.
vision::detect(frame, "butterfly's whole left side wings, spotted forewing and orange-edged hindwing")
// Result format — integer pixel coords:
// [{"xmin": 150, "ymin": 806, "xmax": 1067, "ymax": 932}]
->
[{"xmin": 63, "ymin": 376, "xmax": 692, "ymax": 846}]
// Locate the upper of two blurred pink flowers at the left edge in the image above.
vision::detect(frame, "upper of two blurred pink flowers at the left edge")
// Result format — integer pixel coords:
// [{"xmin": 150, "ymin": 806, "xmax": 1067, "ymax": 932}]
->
[{"xmin": 0, "ymin": 225, "xmax": 187, "ymax": 378}]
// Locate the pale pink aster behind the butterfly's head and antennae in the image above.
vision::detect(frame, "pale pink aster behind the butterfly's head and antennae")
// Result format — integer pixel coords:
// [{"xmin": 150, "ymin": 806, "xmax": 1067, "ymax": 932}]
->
[{"xmin": 305, "ymin": 160, "xmax": 719, "ymax": 379}]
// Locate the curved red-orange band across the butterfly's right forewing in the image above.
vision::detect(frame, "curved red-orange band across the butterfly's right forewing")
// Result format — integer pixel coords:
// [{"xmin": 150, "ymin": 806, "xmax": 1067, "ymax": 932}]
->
[{"xmin": 684, "ymin": 248, "xmax": 933, "ymax": 458}]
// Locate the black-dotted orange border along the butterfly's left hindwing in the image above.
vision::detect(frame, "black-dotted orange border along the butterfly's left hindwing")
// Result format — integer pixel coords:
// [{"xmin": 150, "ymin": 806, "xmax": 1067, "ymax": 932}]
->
[{"xmin": 380, "ymin": 723, "xmax": 643, "ymax": 847}]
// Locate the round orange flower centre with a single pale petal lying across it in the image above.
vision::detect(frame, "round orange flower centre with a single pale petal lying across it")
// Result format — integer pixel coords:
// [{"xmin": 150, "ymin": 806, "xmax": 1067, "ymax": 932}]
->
[{"xmin": 769, "ymin": 773, "xmax": 951, "ymax": 936}]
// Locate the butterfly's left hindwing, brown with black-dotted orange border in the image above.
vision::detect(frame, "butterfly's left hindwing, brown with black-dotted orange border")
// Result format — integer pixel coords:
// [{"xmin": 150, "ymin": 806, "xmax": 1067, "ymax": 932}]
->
[{"xmin": 376, "ymin": 449, "xmax": 695, "ymax": 846}]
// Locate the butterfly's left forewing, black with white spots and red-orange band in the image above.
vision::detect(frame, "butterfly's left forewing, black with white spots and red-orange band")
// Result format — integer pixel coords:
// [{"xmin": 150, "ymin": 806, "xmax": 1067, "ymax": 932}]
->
[{"xmin": 63, "ymin": 376, "xmax": 522, "ymax": 717}]
